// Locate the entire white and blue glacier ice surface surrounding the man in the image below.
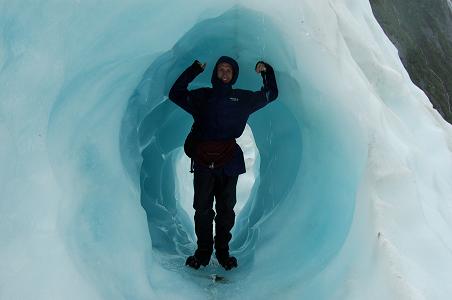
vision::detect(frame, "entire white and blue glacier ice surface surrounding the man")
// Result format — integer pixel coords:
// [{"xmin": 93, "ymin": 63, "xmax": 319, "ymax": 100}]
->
[{"xmin": 0, "ymin": 0, "xmax": 452, "ymax": 299}]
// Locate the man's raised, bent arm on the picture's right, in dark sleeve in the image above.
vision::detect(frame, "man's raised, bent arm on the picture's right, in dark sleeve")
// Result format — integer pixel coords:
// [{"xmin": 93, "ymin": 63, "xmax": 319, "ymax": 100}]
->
[{"xmin": 249, "ymin": 61, "xmax": 278, "ymax": 114}]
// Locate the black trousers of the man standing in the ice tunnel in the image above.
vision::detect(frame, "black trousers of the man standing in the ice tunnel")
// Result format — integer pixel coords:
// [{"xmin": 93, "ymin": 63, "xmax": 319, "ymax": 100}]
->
[{"xmin": 193, "ymin": 171, "xmax": 238, "ymax": 257}]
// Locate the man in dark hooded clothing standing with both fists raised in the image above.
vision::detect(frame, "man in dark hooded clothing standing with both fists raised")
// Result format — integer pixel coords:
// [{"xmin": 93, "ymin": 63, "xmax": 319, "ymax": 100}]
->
[{"xmin": 169, "ymin": 56, "xmax": 278, "ymax": 270}]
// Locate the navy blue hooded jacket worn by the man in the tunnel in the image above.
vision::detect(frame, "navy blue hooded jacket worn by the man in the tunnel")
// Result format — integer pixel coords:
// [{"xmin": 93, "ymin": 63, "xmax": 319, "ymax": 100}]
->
[{"xmin": 169, "ymin": 56, "xmax": 278, "ymax": 176}]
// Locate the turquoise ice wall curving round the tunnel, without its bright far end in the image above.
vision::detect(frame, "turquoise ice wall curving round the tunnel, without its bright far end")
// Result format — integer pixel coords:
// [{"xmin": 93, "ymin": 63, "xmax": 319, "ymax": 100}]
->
[{"xmin": 121, "ymin": 7, "xmax": 363, "ymax": 297}]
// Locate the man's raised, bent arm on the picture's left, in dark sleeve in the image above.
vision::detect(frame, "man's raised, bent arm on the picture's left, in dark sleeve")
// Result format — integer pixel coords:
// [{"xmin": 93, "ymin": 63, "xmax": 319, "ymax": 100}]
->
[{"xmin": 168, "ymin": 60, "xmax": 205, "ymax": 114}]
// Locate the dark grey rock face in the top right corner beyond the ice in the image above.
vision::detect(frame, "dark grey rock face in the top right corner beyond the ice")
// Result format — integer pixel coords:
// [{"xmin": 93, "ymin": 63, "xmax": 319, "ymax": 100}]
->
[{"xmin": 370, "ymin": 0, "xmax": 452, "ymax": 123}]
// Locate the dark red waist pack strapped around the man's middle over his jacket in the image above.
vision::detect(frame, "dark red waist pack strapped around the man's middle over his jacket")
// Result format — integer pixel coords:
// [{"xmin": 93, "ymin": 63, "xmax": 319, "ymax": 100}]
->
[{"xmin": 184, "ymin": 131, "xmax": 236, "ymax": 173}]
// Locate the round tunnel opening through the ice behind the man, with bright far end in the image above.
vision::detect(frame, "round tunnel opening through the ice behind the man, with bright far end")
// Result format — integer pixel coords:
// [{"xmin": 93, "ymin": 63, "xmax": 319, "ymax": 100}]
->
[{"xmin": 122, "ymin": 7, "xmax": 302, "ymax": 268}]
